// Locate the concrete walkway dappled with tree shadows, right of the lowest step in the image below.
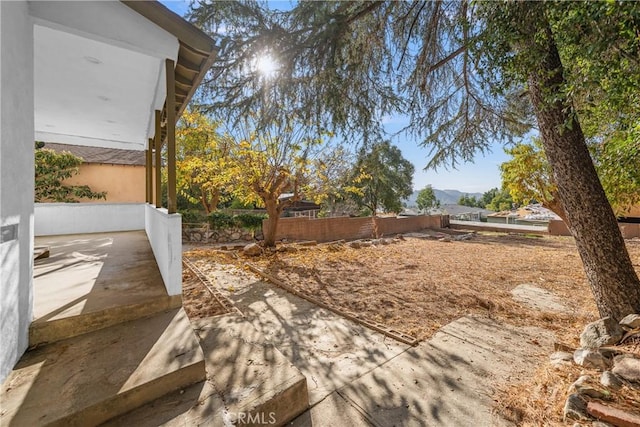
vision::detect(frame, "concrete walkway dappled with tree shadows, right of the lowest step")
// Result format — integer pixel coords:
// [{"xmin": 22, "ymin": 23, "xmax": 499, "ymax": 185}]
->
[{"xmin": 230, "ymin": 270, "xmax": 552, "ymax": 426}]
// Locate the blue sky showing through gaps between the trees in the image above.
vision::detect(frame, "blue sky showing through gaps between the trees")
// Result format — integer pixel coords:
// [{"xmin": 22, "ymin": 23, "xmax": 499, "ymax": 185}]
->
[{"xmin": 161, "ymin": 0, "xmax": 509, "ymax": 193}]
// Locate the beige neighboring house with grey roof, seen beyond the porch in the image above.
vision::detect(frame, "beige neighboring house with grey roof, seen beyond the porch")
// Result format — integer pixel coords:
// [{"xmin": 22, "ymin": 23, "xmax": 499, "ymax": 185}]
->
[{"xmin": 44, "ymin": 142, "xmax": 155, "ymax": 203}]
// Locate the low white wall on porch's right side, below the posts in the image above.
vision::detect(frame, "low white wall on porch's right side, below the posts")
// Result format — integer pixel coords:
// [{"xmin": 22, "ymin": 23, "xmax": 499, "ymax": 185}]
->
[{"xmin": 145, "ymin": 204, "xmax": 182, "ymax": 295}]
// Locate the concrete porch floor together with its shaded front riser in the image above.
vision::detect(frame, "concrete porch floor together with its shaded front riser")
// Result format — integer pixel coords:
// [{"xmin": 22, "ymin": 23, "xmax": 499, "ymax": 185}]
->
[{"xmin": 30, "ymin": 231, "xmax": 181, "ymax": 346}]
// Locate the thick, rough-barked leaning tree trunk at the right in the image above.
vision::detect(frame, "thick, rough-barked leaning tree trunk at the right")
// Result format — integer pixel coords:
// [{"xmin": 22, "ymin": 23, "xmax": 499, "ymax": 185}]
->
[{"xmin": 525, "ymin": 12, "xmax": 640, "ymax": 320}]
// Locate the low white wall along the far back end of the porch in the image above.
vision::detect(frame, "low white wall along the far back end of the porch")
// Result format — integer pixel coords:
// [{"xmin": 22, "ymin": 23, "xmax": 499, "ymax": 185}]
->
[{"xmin": 35, "ymin": 203, "xmax": 145, "ymax": 236}]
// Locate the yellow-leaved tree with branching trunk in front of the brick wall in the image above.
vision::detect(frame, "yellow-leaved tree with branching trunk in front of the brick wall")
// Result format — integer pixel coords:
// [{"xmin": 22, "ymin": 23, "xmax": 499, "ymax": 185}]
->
[{"xmin": 229, "ymin": 118, "xmax": 322, "ymax": 247}]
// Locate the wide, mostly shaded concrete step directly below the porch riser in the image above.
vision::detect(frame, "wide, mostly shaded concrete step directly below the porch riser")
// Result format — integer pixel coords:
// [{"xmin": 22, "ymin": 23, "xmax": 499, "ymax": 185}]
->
[{"xmin": 0, "ymin": 309, "xmax": 205, "ymax": 426}]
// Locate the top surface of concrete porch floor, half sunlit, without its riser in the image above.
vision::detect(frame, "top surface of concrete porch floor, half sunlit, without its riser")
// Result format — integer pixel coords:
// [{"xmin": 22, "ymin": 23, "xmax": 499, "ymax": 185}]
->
[{"xmin": 34, "ymin": 231, "xmax": 167, "ymax": 321}]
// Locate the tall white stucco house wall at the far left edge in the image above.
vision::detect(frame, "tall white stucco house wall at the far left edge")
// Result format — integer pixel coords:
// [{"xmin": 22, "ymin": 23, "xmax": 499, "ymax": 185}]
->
[{"xmin": 0, "ymin": 1, "xmax": 34, "ymax": 383}]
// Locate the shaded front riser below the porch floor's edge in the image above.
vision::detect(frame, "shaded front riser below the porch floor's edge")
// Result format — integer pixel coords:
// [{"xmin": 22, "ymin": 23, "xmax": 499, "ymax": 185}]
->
[{"xmin": 29, "ymin": 295, "xmax": 182, "ymax": 348}]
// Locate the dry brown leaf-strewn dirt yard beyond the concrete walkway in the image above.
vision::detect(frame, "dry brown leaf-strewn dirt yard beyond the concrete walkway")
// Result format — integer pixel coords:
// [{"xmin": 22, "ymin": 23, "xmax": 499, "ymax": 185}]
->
[{"xmin": 186, "ymin": 233, "xmax": 640, "ymax": 345}]
